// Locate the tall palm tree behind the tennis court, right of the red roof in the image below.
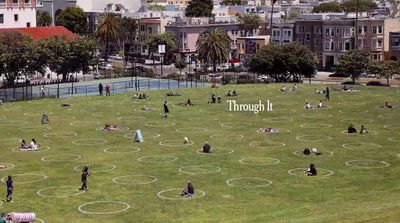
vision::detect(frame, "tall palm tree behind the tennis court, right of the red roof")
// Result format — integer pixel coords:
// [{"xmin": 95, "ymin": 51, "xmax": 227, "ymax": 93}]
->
[{"xmin": 96, "ymin": 12, "xmax": 122, "ymax": 61}]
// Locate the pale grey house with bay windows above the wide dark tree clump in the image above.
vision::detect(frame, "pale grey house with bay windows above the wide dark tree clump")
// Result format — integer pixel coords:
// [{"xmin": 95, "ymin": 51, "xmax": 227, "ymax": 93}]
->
[{"xmin": 271, "ymin": 23, "xmax": 294, "ymax": 45}]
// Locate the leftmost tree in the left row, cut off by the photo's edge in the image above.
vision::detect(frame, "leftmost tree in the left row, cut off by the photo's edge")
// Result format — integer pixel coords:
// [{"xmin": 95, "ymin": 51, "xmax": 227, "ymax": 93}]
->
[{"xmin": 0, "ymin": 31, "xmax": 34, "ymax": 86}]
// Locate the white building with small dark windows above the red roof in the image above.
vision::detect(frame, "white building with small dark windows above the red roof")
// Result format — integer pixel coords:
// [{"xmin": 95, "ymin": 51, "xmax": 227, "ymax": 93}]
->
[{"xmin": 0, "ymin": 0, "xmax": 37, "ymax": 28}]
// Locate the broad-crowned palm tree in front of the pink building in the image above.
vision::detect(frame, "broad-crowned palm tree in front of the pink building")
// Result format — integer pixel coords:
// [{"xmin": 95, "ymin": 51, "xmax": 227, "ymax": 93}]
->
[{"xmin": 196, "ymin": 29, "xmax": 232, "ymax": 72}]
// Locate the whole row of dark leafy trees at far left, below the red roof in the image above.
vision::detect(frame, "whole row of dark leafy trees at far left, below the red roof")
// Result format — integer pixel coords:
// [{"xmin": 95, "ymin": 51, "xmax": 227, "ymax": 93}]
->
[{"xmin": 0, "ymin": 31, "xmax": 98, "ymax": 86}]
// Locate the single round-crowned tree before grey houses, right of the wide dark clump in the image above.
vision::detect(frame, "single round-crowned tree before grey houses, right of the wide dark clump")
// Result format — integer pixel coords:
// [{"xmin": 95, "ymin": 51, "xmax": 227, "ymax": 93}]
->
[{"xmin": 336, "ymin": 50, "xmax": 369, "ymax": 83}]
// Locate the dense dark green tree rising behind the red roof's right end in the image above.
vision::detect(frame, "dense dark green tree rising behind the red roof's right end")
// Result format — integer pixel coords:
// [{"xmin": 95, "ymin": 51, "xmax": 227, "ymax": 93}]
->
[{"xmin": 56, "ymin": 7, "xmax": 87, "ymax": 34}]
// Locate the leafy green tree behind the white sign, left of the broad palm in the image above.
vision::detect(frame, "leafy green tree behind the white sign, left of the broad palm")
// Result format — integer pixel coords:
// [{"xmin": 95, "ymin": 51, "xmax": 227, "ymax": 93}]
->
[{"xmin": 146, "ymin": 32, "xmax": 177, "ymax": 63}]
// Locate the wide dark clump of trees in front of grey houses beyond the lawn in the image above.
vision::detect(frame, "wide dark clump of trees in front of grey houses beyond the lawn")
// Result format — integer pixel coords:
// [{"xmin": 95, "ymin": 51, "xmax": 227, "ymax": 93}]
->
[{"xmin": 248, "ymin": 43, "xmax": 318, "ymax": 82}]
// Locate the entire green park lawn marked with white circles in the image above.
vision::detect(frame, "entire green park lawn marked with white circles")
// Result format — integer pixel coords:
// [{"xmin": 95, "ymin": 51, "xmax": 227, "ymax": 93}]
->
[{"xmin": 0, "ymin": 84, "xmax": 400, "ymax": 223}]
